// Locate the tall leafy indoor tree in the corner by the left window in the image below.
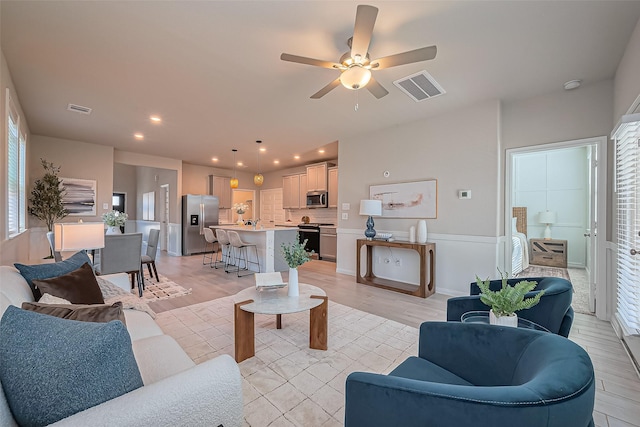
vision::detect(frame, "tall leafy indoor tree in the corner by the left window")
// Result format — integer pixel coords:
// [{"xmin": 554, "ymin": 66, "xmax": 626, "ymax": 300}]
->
[{"xmin": 28, "ymin": 159, "xmax": 69, "ymax": 258}]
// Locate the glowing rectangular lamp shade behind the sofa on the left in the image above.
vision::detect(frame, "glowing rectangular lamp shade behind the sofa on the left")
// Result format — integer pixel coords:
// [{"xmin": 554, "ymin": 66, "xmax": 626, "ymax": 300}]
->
[{"xmin": 53, "ymin": 222, "xmax": 104, "ymax": 252}]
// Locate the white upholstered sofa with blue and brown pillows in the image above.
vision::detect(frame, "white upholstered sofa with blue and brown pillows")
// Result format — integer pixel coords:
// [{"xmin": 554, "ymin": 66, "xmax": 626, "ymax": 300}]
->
[{"xmin": 0, "ymin": 266, "xmax": 243, "ymax": 427}]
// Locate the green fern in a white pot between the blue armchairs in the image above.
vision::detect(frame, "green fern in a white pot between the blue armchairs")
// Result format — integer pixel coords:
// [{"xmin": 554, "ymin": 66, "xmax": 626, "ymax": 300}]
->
[{"xmin": 476, "ymin": 270, "xmax": 544, "ymax": 327}]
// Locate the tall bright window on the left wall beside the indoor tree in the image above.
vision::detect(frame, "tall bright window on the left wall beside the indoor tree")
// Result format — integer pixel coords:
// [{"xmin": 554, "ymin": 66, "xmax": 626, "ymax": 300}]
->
[{"xmin": 6, "ymin": 89, "xmax": 27, "ymax": 237}]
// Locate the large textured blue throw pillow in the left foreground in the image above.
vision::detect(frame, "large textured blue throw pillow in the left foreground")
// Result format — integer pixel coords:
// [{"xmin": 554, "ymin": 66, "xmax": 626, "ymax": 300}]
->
[{"xmin": 0, "ymin": 306, "xmax": 143, "ymax": 426}]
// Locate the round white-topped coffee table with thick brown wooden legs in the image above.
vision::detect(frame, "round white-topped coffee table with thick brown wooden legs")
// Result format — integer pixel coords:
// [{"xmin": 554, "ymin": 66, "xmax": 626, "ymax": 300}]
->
[{"xmin": 233, "ymin": 283, "xmax": 329, "ymax": 363}]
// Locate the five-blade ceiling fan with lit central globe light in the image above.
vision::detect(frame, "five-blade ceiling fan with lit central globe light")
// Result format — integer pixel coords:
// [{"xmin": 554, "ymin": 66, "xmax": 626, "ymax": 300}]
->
[{"xmin": 280, "ymin": 5, "xmax": 437, "ymax": 99}]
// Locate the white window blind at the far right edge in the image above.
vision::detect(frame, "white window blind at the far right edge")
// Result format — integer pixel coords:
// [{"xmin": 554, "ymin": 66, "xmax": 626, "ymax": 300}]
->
[{"xmin": 614, "ymin": 121, "xmax": 640, "ymax": 335}]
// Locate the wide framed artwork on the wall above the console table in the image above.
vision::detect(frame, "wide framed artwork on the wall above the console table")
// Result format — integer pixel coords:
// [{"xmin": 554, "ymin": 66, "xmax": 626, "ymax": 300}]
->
[{"xmin": 369, "ymin": 179, "xmax": 438, "ymax": 219}]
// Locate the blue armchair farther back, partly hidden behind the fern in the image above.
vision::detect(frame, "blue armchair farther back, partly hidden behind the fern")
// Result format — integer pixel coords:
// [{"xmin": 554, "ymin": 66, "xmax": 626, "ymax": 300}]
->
[{"xmin": 447, "ymin": 277, "xmax": 573, "ymax": 337}]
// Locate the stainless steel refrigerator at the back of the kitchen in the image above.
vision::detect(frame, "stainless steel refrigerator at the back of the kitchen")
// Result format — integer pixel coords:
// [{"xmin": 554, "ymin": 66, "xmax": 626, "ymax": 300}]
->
[{"xmin": 182, "ymin": 194, "xmax": 218, "ymax": 255}]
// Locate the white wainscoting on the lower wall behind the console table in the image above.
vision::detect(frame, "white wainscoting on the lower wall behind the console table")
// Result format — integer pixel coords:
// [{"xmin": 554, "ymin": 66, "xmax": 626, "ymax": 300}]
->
[{"xmin": 336, "ymin": 228, "xmax": 504, "ymax": 296}]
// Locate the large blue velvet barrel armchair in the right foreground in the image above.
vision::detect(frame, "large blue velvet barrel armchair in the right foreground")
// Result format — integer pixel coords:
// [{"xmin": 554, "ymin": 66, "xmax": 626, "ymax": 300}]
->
[{"xmin": 345, "ymin": 322, "xmax": 595, "ymax": 427}]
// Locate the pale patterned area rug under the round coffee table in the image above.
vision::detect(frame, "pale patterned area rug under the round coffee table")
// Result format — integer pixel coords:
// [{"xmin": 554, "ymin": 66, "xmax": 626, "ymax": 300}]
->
[{"xmin": 156, "ymin": 297, "xmax": 418, "ymax": 427}]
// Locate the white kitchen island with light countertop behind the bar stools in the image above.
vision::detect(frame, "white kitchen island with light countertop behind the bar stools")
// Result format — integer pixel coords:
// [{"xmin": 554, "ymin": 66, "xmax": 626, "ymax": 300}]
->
[{"xmin": 210, "ymin": 225, "xmax": 298, "ymax": 273}]
